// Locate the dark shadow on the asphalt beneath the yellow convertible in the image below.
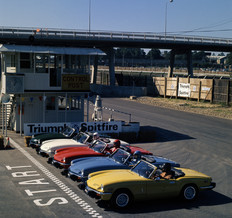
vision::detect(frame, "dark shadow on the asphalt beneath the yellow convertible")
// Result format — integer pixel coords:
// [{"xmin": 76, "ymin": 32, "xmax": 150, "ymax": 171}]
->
[{"xmin": 97, "ymin": 190, "xmax": 232, "ymax": 214}]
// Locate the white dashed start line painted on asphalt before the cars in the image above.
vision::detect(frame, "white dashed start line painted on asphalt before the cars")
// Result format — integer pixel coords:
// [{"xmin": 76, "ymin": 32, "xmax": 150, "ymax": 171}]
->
[{"xmin": 10, "ymin": 139, "xmax": 102, "ymax": 218}]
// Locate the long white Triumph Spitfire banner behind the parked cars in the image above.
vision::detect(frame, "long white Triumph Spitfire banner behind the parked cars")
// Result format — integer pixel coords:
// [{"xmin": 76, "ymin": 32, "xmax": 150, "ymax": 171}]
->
[{"xmin": 24, "ymin": 121, "xmax": 122, "ymax": 136}]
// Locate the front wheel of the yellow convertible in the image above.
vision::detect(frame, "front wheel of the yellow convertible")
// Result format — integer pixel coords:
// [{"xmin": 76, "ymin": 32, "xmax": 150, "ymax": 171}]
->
[{"xmin": 110, "ymin": 190, "xmax": 133, "ymax": 209}]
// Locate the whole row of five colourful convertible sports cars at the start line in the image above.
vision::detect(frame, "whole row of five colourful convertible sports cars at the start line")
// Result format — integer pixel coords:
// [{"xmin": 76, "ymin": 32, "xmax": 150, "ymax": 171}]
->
[{"xmin": 29, "ymin": 127, "xmax": 216, "ymax": 209}]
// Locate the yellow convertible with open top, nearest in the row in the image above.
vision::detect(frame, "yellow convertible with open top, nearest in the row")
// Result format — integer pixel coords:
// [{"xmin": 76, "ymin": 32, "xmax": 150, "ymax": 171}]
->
[{"xmin": 85, "ymin": 160, "xmax": 216, "ymax": 208}]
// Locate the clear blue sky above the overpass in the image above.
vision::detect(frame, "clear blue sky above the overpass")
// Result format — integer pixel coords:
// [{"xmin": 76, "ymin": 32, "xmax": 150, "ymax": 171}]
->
[{"xmin": 0, "ymin": 0, "xmax": 232, "ymax": 39}]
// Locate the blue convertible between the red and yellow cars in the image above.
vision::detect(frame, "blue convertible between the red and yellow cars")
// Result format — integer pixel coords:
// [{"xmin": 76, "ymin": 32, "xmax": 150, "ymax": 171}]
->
[{"xmin": 68, "ymin": 148, "xmax": 180, "ymax": 182}]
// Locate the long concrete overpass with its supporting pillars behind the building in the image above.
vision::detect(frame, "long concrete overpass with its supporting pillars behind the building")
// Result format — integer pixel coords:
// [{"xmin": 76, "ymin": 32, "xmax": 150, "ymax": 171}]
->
[{"xmin": 0, "ymin": 27, "xmax": 232, "ymax": 85}]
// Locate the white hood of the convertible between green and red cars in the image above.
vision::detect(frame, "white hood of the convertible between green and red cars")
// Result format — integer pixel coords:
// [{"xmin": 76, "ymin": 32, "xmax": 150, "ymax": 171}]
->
[{"xmin": 40, "ymin": 139, "xmax": 87, "ymax": 151}]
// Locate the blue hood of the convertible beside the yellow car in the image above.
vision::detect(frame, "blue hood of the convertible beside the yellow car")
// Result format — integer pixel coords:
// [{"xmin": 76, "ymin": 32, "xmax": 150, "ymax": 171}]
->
[{"xmin": 69, "ymin": 157, "xmax": 129, "ymax": 176}]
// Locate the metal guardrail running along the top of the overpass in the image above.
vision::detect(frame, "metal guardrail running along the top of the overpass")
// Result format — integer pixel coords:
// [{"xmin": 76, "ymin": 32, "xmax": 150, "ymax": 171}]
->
[{"xmin": 0, "ymin": 27, "xmax": 232, "ymax": 45}]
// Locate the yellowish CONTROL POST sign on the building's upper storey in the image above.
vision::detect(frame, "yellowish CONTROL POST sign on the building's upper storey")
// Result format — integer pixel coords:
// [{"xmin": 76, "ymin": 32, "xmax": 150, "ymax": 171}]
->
[{"xmin": 62, "ymin": 74, "xmax": 90, "ymax": 91}]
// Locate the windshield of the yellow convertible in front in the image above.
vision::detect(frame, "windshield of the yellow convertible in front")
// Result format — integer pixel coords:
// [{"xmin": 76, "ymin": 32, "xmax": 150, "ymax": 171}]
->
[{"xmin": 131, "ymin": 161, "xmax": 157, "ymax": 179}]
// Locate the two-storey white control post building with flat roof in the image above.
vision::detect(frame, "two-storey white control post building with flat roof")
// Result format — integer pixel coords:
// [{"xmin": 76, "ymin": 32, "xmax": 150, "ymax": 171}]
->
[{"xmin": 0, "ymin": 44, "xmax": 104, "ymax": 133}]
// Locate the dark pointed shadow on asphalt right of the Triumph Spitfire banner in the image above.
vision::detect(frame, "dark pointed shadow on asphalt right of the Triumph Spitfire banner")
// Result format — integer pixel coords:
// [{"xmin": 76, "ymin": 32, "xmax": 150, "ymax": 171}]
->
[{"xmin": 138, "ymin": 126, "xmax": 195, "ymax": 143}]
